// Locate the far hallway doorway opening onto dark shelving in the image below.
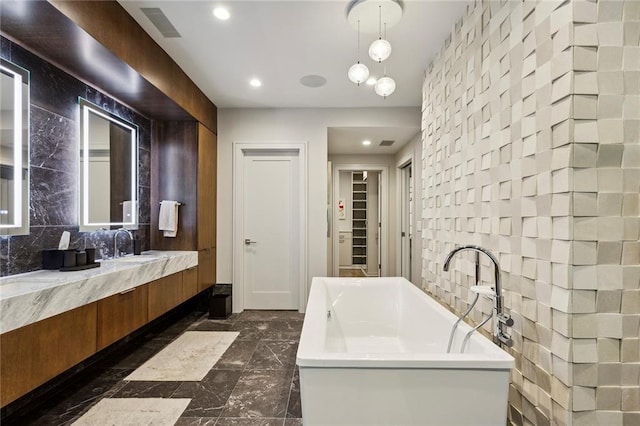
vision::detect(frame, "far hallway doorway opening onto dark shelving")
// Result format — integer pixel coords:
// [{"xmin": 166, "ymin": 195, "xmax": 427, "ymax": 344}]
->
[{"xmin": 332, "ymin": 165, "xmax": 388, "ymax": 277}]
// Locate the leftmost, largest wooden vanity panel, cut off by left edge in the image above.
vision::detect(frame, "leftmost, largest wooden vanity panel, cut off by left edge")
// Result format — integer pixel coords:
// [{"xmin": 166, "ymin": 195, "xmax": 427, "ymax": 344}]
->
[{"xmin": 0, "ymin": 302, "xmax": 97, "ymax": 407}]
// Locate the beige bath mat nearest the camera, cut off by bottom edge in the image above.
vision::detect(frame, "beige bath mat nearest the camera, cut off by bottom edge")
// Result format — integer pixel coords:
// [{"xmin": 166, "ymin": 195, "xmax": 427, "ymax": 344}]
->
[{"xmin": 73, "ymin": 398, "xmax": 191, "ymax": 426}]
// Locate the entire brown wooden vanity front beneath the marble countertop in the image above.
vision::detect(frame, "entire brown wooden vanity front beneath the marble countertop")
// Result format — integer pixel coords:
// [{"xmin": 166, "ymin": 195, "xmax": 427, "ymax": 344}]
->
[{"xmin": 0, "ymin": 266, "xmax": 200, "ymax": 407}]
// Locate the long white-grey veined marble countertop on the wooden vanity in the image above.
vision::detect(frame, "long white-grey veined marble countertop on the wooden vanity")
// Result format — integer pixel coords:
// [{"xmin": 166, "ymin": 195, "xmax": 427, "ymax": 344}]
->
[{"xmin": 0, "ymin": 250, "xmax": 198, "ymax": 333}]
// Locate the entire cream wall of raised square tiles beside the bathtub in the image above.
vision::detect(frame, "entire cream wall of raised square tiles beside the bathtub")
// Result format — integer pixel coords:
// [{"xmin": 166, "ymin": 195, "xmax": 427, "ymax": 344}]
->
[{"xmin": 422, "ymin": 0, "xmax": 640, "ymax": 425}]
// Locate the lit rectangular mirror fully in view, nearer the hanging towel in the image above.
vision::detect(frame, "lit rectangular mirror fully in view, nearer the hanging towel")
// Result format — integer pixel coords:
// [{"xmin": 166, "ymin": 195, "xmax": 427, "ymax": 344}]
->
[{"xmin": 79, "ymin": 99, "xmax": 138, "ymax": 231}]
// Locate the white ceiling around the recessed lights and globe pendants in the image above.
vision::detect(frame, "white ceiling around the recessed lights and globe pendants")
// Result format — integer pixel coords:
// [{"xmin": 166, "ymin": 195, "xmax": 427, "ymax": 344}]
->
[{"xmin": 119, "ymin": 0, "xmax": 468, "ymax": 154}]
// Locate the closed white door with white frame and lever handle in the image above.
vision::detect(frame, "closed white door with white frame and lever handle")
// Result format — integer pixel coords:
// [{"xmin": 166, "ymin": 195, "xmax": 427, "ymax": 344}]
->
[{"xmin": 233, "ymin": 143, "xmax": 307, "ymax": 312}]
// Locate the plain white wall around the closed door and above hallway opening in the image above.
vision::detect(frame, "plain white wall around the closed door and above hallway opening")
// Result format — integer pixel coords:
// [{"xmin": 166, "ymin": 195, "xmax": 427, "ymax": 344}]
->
[{"xmin": 217, "ymin": 107, "xmax": 421, "ymax": 292}]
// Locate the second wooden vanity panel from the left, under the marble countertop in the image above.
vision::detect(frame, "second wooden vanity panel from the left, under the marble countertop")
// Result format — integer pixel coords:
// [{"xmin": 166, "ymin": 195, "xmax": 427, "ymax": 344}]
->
[{"xmin": 97, "ymin": 284, "xmax": 149, "ymax": 350}]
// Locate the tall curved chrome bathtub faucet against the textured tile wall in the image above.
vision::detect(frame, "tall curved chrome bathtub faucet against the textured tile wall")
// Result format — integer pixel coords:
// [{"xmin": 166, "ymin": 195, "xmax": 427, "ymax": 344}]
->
[{"xmin": 442, "ymin": 245, "xmax": 513, "ymax": 347}]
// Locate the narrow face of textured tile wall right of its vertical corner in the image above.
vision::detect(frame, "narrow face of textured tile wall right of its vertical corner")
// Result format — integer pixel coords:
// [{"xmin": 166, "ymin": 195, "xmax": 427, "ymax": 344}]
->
[{"xmin": 568, "ymin": 0, "xmax": 640, "ymax": 425}]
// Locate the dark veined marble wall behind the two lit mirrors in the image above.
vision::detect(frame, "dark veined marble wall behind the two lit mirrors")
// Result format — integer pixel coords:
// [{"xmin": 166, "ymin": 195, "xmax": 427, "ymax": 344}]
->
[{"xmin": 0, "ymin": 37, "xmax": 151, "ymax": 276}]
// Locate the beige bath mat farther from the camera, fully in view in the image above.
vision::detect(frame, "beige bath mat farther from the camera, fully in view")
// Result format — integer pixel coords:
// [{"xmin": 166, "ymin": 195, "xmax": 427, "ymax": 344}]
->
[{"xmin": 125, "ymin": 331, "xmax": 240, "ymax": 382}]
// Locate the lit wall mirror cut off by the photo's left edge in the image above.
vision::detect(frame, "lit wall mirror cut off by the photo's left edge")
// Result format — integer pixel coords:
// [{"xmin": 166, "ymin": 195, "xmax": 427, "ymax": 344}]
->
[{"xmin": 0, "ymin": 59, "xmax": 29, "ymax": 235}]
